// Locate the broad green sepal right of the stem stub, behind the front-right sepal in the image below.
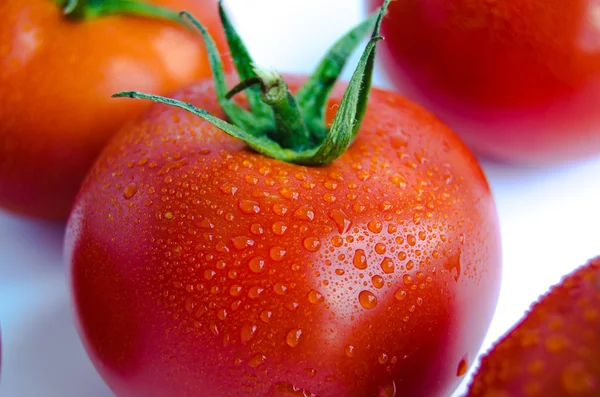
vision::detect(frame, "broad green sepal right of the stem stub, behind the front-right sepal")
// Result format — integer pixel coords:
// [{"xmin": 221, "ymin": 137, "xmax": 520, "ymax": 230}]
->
[{"xmin": 296, "ymin": 13, "xmax": 379, "ymax": 142}]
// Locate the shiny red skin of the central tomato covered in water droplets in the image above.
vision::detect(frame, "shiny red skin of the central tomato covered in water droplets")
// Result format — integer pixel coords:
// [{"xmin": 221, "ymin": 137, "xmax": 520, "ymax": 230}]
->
[{"xmin": 65, "ymin": 76, "xmax": 500, "ymax": 397}]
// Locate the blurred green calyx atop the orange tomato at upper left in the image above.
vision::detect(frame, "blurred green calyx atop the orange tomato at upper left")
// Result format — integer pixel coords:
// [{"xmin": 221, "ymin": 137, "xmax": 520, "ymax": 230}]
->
[{"xmin": 57, "ymin": 0, "xmax": 179, "ymax": 22}]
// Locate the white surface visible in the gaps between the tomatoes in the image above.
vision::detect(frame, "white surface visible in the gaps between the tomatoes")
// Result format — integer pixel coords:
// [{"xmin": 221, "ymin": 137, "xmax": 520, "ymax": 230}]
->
[{"xmin": 0, "ymin": 0, "xmax": 600, "ymax": 397}]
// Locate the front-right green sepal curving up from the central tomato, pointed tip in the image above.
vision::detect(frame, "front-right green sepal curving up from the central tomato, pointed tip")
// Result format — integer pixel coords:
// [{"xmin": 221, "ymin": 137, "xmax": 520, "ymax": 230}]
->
[{"xmin": 296, "ymin": 36, "xmax": 382, "ymax": 165}]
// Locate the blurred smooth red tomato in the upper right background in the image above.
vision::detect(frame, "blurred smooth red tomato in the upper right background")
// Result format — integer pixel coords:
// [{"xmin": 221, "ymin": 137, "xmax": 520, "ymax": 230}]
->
[{"xmin": 368, "ymin": 0, "xmax": 600, "ymax": 164}]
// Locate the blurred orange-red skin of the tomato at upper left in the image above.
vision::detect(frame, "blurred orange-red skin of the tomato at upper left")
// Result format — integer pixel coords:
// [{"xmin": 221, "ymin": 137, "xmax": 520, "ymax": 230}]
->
[{"xmin": 0, "ymin": 0, "xmax": 229, "ymax": 220}]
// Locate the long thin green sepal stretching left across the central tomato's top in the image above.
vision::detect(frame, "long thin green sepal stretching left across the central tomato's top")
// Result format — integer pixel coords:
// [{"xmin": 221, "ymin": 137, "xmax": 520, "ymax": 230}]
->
[{"xmin": 112, "ymin": 91, "xmax": 297, "ymax": 162}]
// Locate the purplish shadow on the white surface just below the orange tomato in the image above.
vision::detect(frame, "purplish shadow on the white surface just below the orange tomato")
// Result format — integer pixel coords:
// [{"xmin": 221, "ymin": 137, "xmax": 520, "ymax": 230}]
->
[{"xmin": 0, "ymin": 210, "xmax": 65, "ymax": 280}]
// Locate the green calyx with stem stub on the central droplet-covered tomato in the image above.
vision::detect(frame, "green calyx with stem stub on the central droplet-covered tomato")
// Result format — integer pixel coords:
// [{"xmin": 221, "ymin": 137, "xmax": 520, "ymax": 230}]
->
[{"xmin": 113, "ymin": 0, "xmax": 391, "ymax": 166}]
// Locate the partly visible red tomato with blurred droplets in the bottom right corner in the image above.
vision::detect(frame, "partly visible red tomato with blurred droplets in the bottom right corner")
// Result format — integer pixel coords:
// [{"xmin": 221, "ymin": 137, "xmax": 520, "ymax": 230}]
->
[{"xmin": 468, "ymin": 257, "xmax": 600, "ymax": 397}]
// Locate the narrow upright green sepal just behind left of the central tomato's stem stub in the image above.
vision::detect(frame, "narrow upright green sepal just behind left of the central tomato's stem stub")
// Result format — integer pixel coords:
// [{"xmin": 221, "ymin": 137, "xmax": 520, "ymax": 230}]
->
[{"xmin": 219, "ymin": 0, "xmax": 271, "ymax": 120}]
